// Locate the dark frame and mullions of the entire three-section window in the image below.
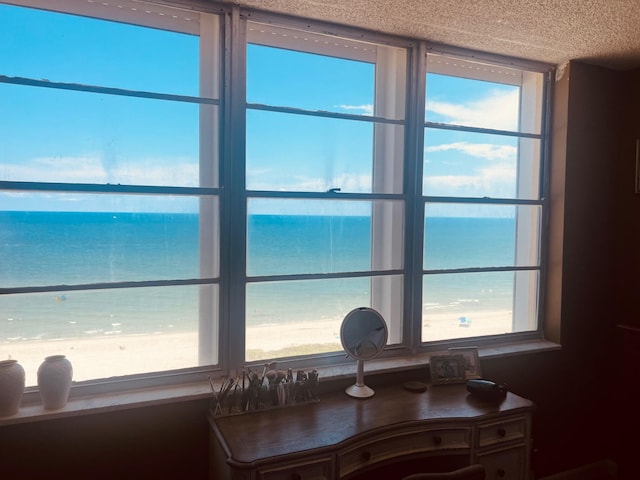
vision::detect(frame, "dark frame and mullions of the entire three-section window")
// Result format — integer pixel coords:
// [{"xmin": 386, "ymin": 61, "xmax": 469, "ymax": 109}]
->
[{"xmin": 0, "ymin": 0, "xmax": 554, "ymax": 393}]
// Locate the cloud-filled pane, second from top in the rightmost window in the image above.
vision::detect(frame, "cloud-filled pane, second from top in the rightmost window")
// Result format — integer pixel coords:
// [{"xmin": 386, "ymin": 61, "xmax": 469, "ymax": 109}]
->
[{"xmin": 422, "ymin": 128, "xmax": 540, "ymax": 199}]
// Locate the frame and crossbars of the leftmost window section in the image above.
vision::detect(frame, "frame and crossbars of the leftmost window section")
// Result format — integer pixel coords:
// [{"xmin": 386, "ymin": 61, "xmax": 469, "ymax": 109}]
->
[{"xmin": 0, "ymin": 0, "xmax": 224, "ymax": 394}]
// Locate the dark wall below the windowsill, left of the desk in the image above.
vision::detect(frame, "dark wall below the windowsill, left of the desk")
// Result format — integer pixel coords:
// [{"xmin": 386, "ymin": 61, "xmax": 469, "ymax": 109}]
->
[{"xmin": 0, "ymin": 401, "xmax": 209, "ymax": 480}]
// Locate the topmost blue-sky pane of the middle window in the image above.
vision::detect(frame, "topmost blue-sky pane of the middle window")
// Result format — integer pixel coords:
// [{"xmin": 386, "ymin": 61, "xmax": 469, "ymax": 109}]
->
[{"xmin": 247, "ymin": 40, "xmax": 375, "ymax": 115}]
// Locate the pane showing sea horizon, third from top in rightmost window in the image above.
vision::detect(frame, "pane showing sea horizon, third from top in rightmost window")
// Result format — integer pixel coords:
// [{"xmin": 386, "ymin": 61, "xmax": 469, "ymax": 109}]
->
[{"xmin": 424, "ymin": 204, "xmax": 540, "ymax": 270}]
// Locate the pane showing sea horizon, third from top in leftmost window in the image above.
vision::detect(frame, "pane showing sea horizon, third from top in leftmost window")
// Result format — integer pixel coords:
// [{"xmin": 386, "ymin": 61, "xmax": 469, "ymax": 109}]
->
[{"xmin": 0, "ymin": 193, "xmax": 218, "ymax": 287}]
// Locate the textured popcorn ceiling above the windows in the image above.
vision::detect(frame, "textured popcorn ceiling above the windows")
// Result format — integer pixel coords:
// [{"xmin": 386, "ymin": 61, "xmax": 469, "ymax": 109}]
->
[{"xmin": 227, "ymin": 0, "xmax": 640, "ymax": 70}]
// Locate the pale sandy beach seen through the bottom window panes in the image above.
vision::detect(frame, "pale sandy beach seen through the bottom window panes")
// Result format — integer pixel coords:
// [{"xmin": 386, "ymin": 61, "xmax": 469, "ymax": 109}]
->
[{"xmin": 0, "ymin": 311, "xmax": 511, "ymax": 385}]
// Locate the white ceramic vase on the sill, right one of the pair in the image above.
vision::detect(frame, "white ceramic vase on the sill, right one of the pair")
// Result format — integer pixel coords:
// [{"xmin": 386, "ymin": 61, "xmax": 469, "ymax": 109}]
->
[{"xmin": 38, "ymin": 355, "xmax": 73, "ymax": 410}]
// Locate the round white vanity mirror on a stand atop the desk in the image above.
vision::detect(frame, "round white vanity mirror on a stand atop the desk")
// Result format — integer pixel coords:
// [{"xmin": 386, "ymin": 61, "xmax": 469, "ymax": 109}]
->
[{"xmin": 340, "ymin": 307, "xmax": 389, "ymax": 398}]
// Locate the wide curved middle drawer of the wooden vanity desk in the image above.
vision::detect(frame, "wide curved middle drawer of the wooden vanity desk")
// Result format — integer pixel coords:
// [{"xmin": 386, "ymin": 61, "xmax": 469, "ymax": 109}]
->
[{"xmin": 338, "ymin": 428, "xmax": 471, "ymax": 477}]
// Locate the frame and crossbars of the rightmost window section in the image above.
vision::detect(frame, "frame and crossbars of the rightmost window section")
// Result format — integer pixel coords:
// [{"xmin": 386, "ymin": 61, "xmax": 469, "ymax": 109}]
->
[{"xmin": 416, "ymin": 49, "xmax": 554, "ymax": 351}]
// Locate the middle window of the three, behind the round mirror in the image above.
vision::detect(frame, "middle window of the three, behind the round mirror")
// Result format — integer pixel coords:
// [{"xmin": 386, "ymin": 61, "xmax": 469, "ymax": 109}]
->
[{"xmin": 243, "ymin": 22, "xmax": 407, "ymax": 360}]
